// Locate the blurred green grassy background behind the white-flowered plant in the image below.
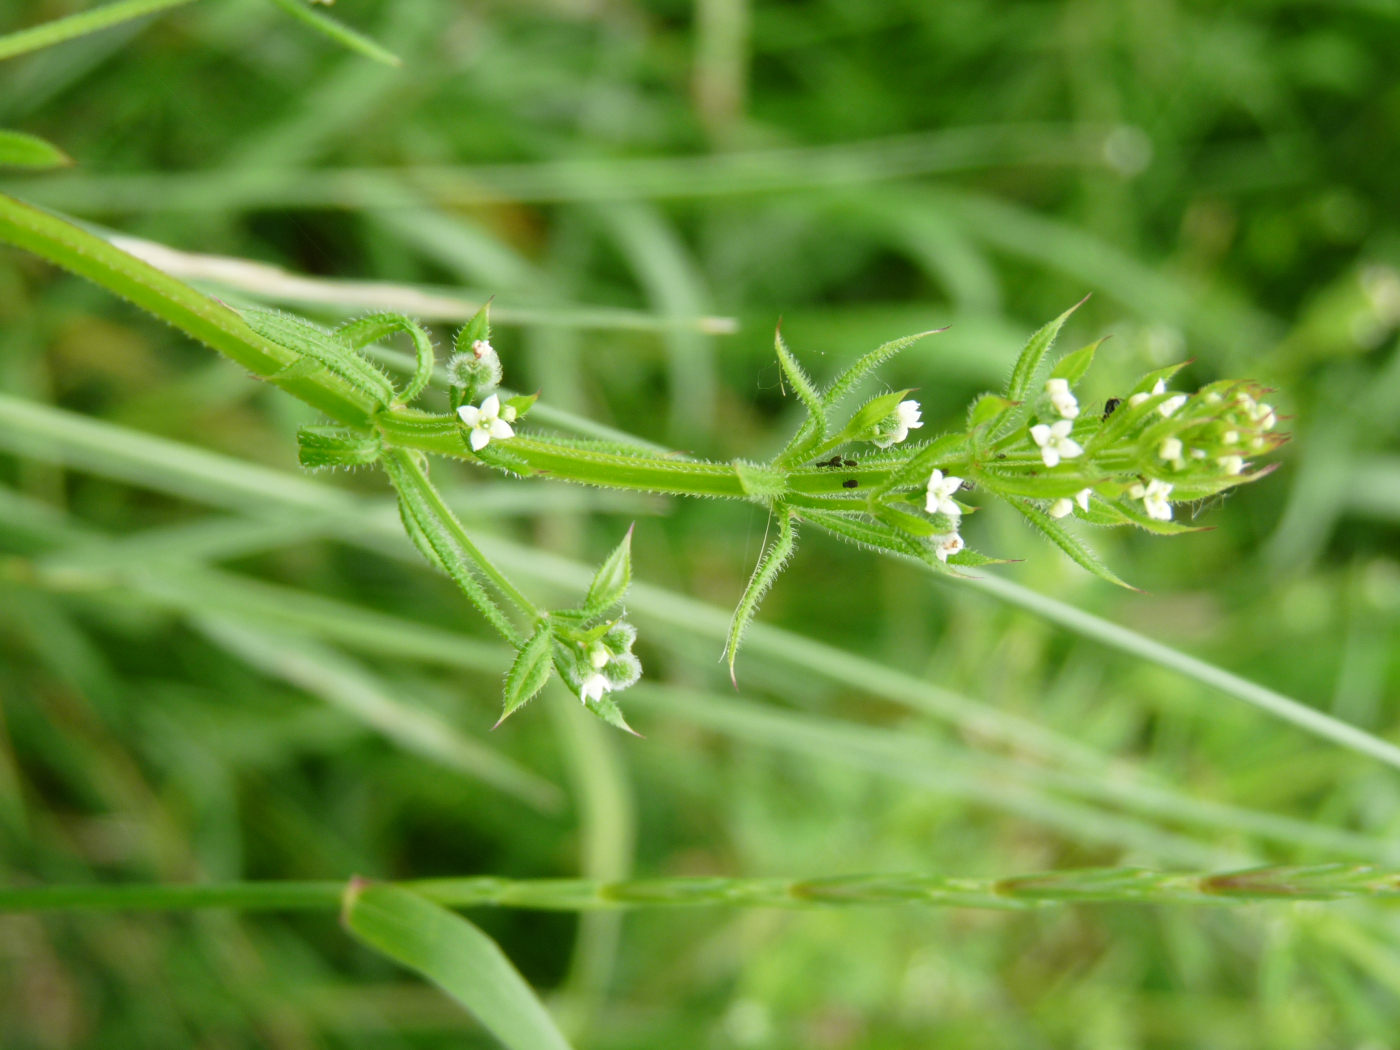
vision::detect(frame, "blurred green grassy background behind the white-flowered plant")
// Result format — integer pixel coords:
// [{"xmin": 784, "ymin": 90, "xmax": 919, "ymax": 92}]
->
[{"xmin": 0, "ymin": 0, "xmax": 1400, "ymax": 1050}]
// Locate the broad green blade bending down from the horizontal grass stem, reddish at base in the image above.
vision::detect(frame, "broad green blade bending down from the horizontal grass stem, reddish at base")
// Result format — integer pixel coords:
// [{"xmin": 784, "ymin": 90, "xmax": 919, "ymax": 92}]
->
[{"xmin": 342, "ymin": 879, "xmax": 568, "ymax": 1050}]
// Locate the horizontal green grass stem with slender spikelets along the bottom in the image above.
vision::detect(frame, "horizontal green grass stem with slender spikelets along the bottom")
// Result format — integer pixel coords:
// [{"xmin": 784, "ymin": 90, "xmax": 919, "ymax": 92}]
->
[{"xmin": 8, "ymin": 864, "xmax": 1400, "ymax": 911}]
